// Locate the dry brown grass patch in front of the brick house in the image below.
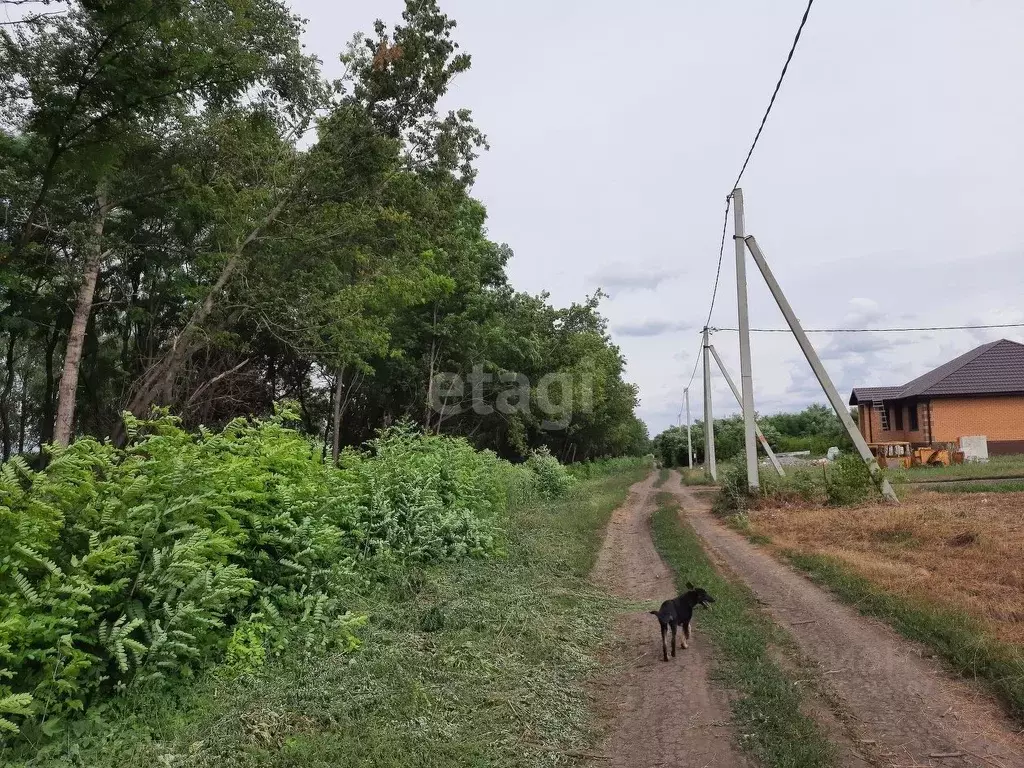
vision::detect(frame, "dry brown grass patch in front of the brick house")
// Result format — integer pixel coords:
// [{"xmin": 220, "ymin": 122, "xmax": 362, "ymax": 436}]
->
[{"xmin": 750, "ymin": 492, "xmax": 1024, "ymax": 644}]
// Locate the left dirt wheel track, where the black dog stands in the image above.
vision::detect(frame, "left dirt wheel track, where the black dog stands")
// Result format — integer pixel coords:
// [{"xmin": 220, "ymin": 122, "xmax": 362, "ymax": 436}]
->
[{"xmin": 593, "ymin": 475, "xmax": 750, "ymax": 768}]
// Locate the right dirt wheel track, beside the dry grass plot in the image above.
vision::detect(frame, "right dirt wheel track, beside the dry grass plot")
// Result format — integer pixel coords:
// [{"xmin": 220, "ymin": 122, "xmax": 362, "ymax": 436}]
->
[{"xmin": 665, "ymin": 472, "xmax": 1024, "ymax": 768}]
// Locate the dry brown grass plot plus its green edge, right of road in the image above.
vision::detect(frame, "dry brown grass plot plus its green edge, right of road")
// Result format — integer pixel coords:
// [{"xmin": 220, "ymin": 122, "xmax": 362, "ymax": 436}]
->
[{"xmin": 734, "ymin": 493, "xmax": 1024, "ymax": 721}]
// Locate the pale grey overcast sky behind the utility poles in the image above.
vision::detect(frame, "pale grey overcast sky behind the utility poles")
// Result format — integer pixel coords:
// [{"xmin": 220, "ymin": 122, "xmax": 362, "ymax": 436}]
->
[{"xmin": 292, "ymin": 0, "xmax": 1024, "ymax": 435}]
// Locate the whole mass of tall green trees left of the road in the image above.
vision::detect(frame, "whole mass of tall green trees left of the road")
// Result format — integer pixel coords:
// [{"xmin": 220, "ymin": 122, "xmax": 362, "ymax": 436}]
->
[{"xmin": 0, "ymin": 0, "xmax": 647, "ymax": 460}]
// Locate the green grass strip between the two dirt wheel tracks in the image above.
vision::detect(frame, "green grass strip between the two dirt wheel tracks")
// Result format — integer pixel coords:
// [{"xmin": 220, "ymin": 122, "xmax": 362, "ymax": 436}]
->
[{"xmin": 652, "ymin": 493, "xmax": 838, "ymax": 768}]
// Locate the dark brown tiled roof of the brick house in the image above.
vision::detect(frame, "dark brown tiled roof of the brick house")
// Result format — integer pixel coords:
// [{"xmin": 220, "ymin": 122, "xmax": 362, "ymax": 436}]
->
[{"xmin": 850, "ymin": 339, "xmax": 1024, "ymax": 406}]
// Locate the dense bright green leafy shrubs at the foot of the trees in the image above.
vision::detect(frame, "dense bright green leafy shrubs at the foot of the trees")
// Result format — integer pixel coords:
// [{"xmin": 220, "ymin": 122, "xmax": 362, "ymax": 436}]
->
[{"xmin": 0, "ymin": 411, "xmax": 509, "ymax": 736}]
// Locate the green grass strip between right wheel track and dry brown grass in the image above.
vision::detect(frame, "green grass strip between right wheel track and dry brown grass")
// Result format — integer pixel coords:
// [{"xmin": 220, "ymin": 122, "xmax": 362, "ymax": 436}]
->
[{"xmin": 782, "ymin": 551, "xmax": 1024, "ymax": 722}]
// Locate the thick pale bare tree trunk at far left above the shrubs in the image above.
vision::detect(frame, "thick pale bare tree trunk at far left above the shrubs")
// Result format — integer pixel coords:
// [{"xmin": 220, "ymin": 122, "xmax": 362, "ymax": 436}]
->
[{"xmin": 53, "ymin": 195, "xmax": 110, "ymax": 445}]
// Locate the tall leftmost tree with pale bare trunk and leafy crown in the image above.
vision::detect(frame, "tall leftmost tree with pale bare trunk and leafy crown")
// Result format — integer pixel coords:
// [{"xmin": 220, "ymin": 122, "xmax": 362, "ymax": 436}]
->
[{"xmin": 0, "ymin": 0, "xmax": 312, "ymax": 444}]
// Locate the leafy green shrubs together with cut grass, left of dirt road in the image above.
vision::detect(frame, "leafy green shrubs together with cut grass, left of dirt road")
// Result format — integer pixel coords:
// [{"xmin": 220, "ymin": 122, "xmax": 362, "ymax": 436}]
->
[{"xmin": 0, "ymin": 413, "xmax": 649, "ymax": 766}]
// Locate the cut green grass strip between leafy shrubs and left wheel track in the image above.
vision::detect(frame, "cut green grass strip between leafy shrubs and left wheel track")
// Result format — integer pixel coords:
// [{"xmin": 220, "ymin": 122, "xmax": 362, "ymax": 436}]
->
[{"xmin": 8, "ymin": 470, "xmax": 646, "ymax": 768}]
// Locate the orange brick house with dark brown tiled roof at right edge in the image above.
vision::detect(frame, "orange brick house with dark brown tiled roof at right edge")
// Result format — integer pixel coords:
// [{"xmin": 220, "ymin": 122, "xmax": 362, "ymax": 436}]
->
[{"xmin": 850, "ymin": 339, "xmax": 1024, "ymax": 456}]
